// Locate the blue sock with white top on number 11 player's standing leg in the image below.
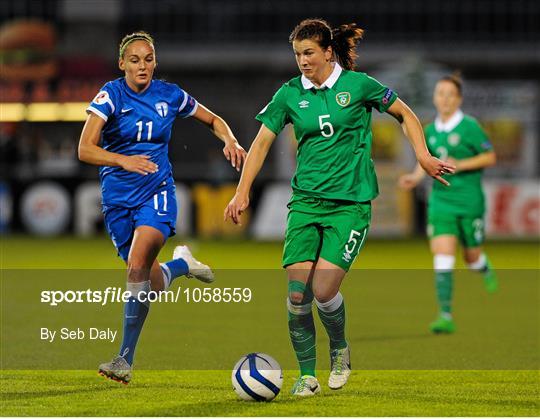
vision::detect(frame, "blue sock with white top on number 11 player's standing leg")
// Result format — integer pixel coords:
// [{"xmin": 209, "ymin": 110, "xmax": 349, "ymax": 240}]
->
[{"xmin": 120, "ymin": 281, "xmax": 150, "ymax": 365}]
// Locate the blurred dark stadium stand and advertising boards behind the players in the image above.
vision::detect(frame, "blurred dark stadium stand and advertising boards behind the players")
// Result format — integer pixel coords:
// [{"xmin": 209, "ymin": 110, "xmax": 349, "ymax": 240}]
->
[{"xmin": 0, "ymin": 0, "xmax": 540, "ymax": 241}]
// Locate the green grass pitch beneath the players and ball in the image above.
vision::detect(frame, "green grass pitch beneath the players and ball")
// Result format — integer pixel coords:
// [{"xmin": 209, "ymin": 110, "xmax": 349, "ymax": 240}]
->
[{"xmin": 0, "ymin": 237, "xmax": 540, "ymax": 416}]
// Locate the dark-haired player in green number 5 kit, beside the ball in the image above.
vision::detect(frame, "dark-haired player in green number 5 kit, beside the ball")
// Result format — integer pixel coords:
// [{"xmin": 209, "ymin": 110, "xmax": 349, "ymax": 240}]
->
[{"xmin": 225, "ymin": 19, "xmax": 454, "ymax": 396}]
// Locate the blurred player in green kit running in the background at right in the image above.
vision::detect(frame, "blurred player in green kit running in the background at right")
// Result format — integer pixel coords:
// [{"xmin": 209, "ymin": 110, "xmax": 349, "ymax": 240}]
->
[{"xmin": 399, "ymin": 75, "xmax": 497, "ymax": 333}]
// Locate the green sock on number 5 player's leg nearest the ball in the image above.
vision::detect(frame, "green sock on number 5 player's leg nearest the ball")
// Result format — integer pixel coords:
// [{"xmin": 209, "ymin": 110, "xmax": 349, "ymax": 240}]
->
[{"xmin": 287, "ymin": 281, "xmax": 317, "ymax": 376}]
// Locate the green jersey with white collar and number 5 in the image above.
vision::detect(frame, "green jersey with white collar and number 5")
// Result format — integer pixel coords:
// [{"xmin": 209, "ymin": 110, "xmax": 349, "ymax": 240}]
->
[{"xmin": 256, "ymin": 63, "xmax": 397, "ymax": 202}]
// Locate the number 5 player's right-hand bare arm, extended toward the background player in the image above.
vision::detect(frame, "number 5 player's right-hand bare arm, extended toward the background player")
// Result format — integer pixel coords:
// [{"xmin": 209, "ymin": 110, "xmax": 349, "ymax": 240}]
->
[{"xmin": 386, "ymin": 98, "xmax": 455, "ymax": 186}]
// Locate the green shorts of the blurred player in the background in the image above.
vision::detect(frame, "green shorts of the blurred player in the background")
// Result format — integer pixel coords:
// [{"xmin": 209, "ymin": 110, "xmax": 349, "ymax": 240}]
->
[{"xmin": 427, "ymin": 212, "xmax": 485, "ymax": 247}]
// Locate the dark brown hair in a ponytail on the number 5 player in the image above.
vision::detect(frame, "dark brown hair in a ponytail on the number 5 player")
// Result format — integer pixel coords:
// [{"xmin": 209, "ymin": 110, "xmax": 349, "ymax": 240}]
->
[{"xmin": 289, "ymin": 19, "xmax": 364, "ymax": 70}]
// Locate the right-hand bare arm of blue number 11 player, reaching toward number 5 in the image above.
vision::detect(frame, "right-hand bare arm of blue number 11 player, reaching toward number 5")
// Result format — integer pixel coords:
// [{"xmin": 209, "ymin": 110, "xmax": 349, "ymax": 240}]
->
[{"xmin": 193, "ymin": 103, "xmax": 247, "ymax": 171}]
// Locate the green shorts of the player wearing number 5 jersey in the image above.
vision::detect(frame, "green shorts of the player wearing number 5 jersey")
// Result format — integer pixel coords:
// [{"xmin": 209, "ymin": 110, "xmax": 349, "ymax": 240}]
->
[{"xmin": 283, "ymin": 196, "xmax": 371, "ymax": 271}]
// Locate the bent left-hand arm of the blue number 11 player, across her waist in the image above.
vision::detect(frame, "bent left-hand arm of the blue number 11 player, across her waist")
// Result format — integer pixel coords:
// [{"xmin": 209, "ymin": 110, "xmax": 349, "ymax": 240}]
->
[{"xmin": 79, "ymin": 112, "xmax": 158, "ymax": 175}]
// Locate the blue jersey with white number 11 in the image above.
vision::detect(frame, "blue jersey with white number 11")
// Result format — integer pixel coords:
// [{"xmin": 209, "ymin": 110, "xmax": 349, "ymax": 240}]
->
[{"xmin": 87, "ymin": 78, "xmax": 198, "ymax": 208}]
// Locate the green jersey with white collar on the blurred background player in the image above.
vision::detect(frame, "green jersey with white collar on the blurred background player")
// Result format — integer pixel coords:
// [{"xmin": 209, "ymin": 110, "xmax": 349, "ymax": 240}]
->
[{"xmin": 425, "ymin": 111, "xmax": 493, "ymax": 216}]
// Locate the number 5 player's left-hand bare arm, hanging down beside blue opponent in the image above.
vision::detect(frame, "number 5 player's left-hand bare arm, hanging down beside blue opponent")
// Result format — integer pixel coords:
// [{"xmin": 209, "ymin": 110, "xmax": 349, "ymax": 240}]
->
[{"xmin": 224, "ymin": 124, "xmax": 276, "ymax": 224}]
